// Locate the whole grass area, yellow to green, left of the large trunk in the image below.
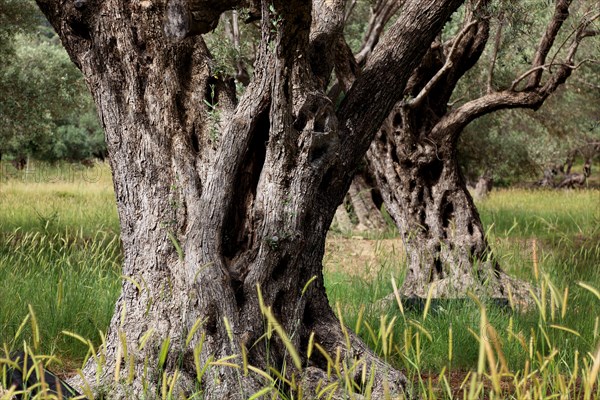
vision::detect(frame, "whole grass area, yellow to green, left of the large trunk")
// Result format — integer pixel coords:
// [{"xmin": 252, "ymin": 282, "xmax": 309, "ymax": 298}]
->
[{"xmin": 0, "ymin": 160, "xmax": 122, "ymax": 359}]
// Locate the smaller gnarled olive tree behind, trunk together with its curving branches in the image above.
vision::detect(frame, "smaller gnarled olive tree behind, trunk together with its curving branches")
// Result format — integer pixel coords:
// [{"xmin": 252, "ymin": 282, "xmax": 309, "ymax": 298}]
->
[{"xmin": 330, "ymin": 1, "xmax": 598, "ymax": 303}]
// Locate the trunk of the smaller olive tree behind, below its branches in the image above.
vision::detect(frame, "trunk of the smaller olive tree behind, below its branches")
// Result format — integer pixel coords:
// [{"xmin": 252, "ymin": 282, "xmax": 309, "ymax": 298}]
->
[{"xmin": 367, "ymin": 122, "xmax": 528, "ymax": 304}]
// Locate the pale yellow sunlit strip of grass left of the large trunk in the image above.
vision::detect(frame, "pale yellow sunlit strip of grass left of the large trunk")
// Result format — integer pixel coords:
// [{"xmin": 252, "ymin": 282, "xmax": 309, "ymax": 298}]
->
[{"xmin": 0, "ymin": 163, "xmax": 119, "ymax": 236}]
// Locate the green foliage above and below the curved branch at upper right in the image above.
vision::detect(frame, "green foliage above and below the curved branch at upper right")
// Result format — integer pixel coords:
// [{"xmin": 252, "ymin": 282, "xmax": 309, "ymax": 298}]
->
[{"xmin": 455, "ymin": 1, "xmax": 600, "ymax": 184}]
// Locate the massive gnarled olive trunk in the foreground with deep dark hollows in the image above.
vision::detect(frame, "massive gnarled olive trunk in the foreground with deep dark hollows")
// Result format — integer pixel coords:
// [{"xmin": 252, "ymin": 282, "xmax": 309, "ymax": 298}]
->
[{"xmin": 38, "ymin": 0, "xmax": 461, "ymax": 400}]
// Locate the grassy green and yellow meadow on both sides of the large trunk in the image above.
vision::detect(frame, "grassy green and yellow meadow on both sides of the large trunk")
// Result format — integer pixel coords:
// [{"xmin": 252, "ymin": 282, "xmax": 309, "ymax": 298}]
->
[{"xmin": 0, "ymin": 164, "xmax": 600, "ymax": 399}]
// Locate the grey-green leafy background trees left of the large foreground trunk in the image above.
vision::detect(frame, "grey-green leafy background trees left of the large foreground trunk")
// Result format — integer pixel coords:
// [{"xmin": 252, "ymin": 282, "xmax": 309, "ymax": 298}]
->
[{"xmin": 0, "ymin": 0, "xmax": 105, "ymax": 166}]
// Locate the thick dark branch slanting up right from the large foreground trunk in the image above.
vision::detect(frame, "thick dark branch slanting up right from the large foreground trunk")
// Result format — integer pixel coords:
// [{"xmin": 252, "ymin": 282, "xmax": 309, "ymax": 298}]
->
[{"xmin": 337, "ymin": 0, "xmax": 462, "ymax": 166}]
